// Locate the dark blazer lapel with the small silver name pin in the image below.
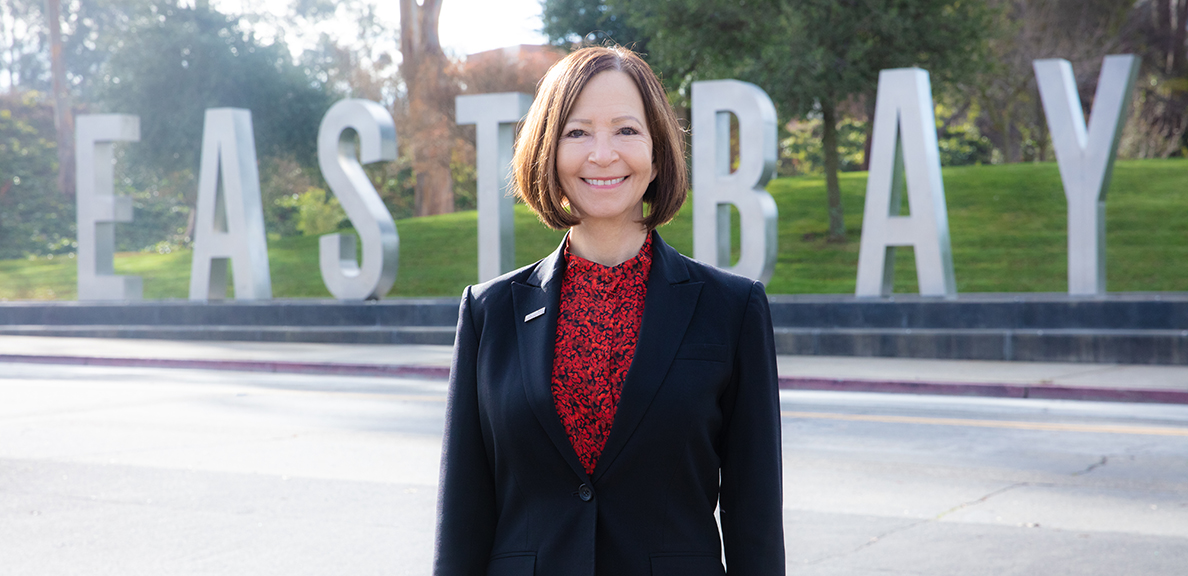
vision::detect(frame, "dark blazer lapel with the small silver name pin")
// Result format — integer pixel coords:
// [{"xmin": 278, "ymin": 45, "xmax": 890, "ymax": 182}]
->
[{"xmin": 512, "ymin": 240, "xmax": 589, "ymax": 480}]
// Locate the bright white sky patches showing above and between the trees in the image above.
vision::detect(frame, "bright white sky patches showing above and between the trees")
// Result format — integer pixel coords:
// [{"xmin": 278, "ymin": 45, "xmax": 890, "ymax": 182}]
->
[{"xmin": 211, "ymin": 0, "xmax": 546, "ymax": 56}]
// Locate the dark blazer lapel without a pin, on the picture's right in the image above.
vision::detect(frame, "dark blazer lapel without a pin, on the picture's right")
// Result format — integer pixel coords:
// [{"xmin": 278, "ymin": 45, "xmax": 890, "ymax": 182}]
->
[{"xmin": 591, "ymin": 232, "xmax": 702, "ymax": 482}]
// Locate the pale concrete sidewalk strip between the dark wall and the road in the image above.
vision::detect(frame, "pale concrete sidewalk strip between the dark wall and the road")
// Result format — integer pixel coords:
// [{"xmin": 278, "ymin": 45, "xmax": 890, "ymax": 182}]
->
[{"xmin": 0, "ymin": 336, "xmax": 1188, "ymax": 404}]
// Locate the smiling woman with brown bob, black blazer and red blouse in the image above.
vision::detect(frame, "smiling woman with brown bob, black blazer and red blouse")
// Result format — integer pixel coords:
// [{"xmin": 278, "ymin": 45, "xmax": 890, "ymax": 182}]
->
[{"xmin": 435, "ymin": 48, "xmax": 784, "ymax": 576}]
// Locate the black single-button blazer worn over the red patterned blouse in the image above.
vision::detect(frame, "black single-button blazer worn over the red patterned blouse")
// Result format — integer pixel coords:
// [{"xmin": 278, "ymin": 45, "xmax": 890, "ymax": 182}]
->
[{"xmin": 434, "ymin": 234, "xmax": 784, "ymax": 576}]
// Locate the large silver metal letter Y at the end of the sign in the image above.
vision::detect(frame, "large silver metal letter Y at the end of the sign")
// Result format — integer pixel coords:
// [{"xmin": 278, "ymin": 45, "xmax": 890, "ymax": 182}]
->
[{"xmin": 1034, "ymin": 55, "xmax": 1139, "ymax": 296}]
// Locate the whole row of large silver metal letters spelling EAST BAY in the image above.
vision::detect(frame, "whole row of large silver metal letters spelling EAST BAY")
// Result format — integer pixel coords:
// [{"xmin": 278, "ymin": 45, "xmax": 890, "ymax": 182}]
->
[{"xmin": 62, "ymin": 55, "xmax": 1139, "ymax": 300}]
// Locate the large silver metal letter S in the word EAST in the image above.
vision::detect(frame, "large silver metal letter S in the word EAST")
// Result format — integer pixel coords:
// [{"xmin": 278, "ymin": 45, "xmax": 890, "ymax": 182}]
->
[{"xmin": 317, "ymin": 100, "xmax": 400, "ymax": 299}]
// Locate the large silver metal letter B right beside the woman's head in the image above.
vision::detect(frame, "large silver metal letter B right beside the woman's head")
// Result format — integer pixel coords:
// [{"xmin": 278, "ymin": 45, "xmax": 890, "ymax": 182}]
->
[{"xmin": 693, "ymin": 80, "xmax": 778, "ymax": 283}]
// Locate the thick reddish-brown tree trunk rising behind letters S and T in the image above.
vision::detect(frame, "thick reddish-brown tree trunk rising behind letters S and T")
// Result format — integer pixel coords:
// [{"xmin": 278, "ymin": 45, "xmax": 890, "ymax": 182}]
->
[{"xmin": 400, "ymin": 0, "xmax": 454, "ymax": 216}]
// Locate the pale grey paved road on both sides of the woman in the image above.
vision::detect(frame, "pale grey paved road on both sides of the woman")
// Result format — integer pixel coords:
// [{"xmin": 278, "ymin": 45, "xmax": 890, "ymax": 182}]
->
[{"xmin": 0, "ymin": 365, "xmax": 1188, "ymax": 576}]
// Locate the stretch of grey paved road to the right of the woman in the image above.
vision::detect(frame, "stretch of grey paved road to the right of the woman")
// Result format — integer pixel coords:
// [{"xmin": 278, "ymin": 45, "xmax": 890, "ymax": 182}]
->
[{"xmin": 784, "ymin": 392, "xmax": 1188, "ymax": 576}]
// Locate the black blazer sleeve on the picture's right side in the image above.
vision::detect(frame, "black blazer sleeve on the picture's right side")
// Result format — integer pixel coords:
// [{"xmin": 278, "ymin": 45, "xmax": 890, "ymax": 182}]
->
[{"xmin": 719, "ymin": 277, "xmax": 784, "ymax": 576}]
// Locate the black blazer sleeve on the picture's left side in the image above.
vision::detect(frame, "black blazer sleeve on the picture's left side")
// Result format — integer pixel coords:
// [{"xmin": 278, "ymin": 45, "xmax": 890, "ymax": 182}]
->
[{"xmin": 434, "ymin": 287, "xmax": 495, "ymax": 576}]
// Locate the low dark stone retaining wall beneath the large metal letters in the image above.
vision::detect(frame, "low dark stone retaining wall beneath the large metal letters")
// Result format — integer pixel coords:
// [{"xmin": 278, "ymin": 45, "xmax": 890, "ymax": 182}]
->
[{"xmin": 0, "ymin": 292, "xmax": 1188, "ymax": 365}]
